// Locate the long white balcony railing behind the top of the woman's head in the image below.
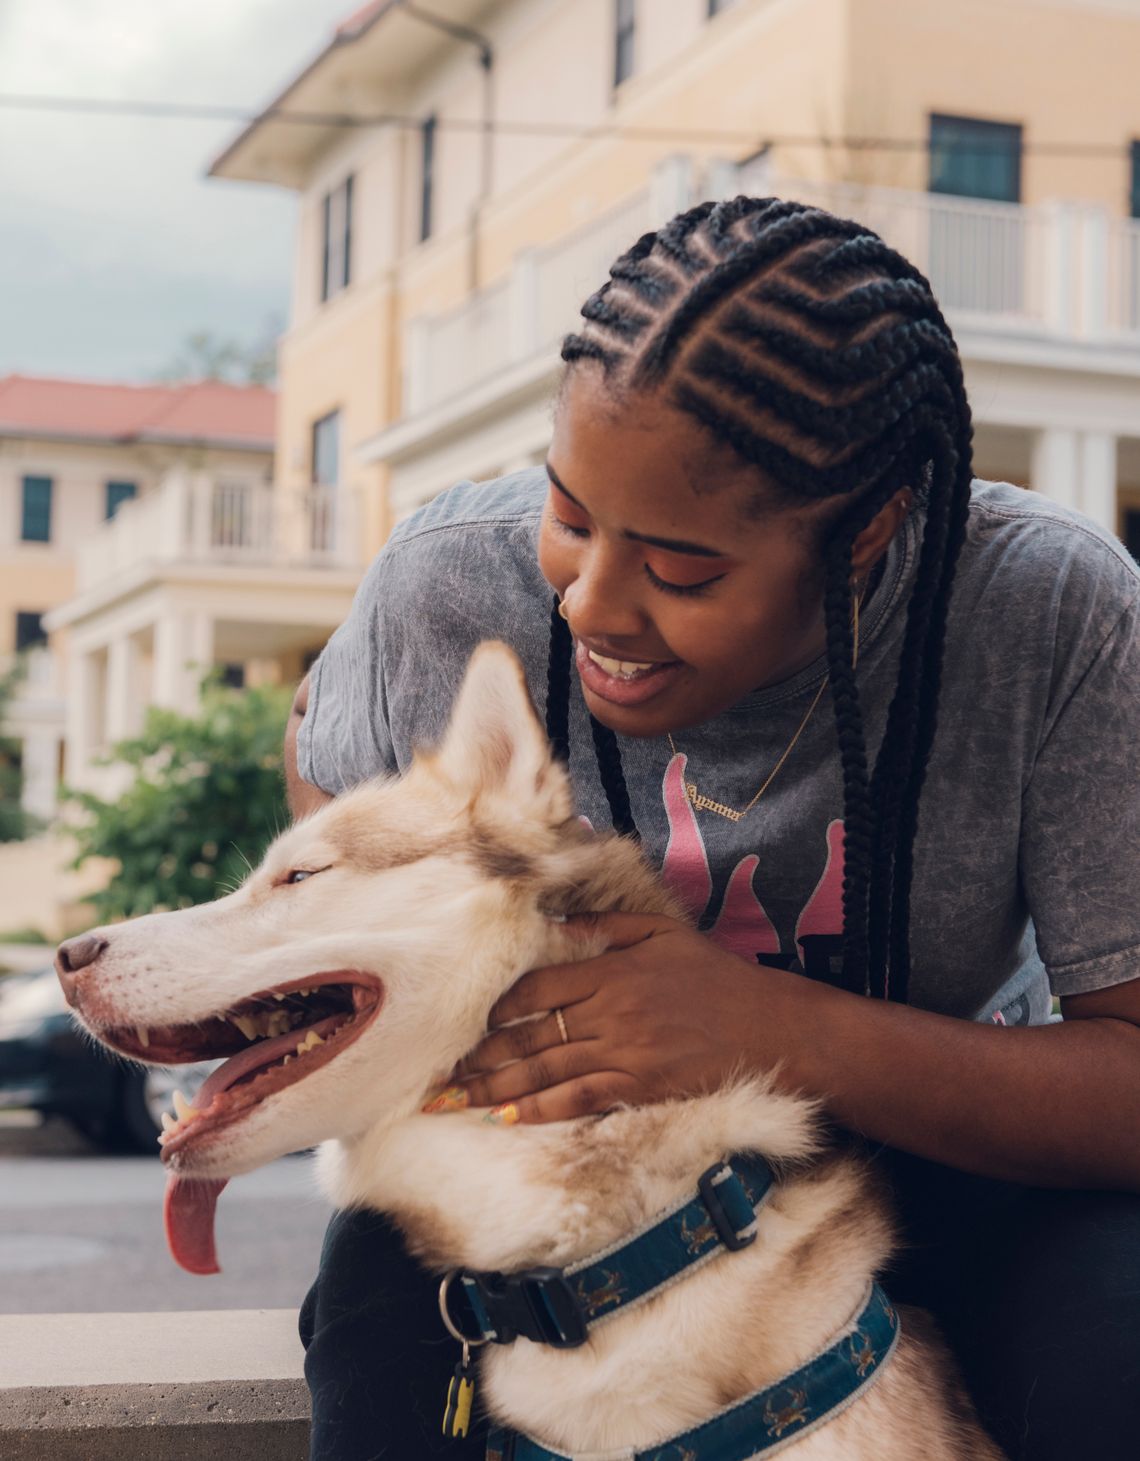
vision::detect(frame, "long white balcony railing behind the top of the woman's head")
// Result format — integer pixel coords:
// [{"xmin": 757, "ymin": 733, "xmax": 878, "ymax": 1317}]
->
[{"xmin": 405, "ymin": 177, "xmax": 1140, "ymax": 419}]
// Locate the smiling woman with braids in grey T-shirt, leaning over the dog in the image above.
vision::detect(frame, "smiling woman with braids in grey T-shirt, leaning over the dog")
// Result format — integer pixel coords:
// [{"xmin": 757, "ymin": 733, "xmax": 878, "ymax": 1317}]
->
[{"xmin": 289, "ymin": 199, "xmax": 1140, "ymax": 1461}]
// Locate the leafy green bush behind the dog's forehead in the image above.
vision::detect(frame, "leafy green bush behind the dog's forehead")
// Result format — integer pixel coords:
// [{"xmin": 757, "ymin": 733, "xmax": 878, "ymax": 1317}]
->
[{"xmin": 66, "ymin": 679, "xmax": 292, "ymax": 922}]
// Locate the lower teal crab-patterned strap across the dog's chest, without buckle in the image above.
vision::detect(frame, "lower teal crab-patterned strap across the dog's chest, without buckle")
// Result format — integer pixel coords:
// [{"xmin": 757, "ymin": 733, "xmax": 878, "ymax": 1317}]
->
[{"xmin": 487, "ymin": 1284, "xmax": 899, "ymax": 1461}]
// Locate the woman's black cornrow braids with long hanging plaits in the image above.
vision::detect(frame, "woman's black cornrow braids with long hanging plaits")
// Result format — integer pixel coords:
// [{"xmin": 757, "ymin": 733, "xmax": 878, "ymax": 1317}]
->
[{"xmin": 548, "ymin": 197, "xmax": 972, "ymax": 1001}]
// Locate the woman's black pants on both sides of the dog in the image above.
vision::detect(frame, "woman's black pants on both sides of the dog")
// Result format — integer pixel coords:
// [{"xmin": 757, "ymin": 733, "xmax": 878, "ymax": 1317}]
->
[{"xmin": 301, "ymin": 1151, "xmax": 1140, "ymax": 1461}]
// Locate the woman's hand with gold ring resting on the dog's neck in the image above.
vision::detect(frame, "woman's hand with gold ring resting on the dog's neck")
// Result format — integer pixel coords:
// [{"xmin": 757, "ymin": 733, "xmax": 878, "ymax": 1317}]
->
[{"xmin": 455, "ymin": 913, "xmax": 766, "ymax": 1121}]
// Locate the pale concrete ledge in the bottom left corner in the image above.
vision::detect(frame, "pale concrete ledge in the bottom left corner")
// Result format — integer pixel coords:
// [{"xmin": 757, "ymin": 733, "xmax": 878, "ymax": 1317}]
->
[{"xmin": 0, "ymin": 1309, "xmax": 308, "ymax": 1461}]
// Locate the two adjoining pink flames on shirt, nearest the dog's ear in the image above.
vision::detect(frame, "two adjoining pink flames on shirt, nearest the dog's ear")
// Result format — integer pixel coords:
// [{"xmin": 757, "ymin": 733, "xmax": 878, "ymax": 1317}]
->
[{"xmin": 661, "ymin": 751, "xmax": 783, "ymax": 958}]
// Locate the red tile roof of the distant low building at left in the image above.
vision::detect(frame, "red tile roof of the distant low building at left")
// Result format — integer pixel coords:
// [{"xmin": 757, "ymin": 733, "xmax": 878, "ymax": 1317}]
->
[{"xmin": 0, "ymin": 375, "xmax": 276, "ymax": 451}]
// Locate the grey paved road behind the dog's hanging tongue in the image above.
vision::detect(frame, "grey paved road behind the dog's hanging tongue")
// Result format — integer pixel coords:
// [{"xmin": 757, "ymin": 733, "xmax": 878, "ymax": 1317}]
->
[{"xmin": 0, "ymin": 1115, "xmax": 329, "ymax": 1313}]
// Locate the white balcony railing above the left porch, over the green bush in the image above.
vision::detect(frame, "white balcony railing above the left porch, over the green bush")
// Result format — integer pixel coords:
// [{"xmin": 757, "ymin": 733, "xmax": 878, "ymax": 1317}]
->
[{"xmin": 76, "ymin": 472, "xmax": 361, "ymax": 593}]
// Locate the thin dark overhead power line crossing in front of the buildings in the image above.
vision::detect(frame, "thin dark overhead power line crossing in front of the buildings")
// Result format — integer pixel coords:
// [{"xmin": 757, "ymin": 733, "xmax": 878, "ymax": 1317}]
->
[{"xmin": 0, "ymin": 92, "xmax": 1130, "ymax": 158}]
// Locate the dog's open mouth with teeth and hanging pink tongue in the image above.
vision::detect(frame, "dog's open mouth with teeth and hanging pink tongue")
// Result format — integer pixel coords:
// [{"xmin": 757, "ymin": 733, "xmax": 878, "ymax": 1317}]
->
[{"xmin": 101, "ymin": 969, "xmax": 384, "ymax": 1274}]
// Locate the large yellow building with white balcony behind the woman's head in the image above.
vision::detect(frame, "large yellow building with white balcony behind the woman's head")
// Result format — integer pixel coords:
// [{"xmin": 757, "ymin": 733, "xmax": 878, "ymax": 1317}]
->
[{"xmin": 212, "ymin": 0, "xmax": 1140, "ymax": 551}]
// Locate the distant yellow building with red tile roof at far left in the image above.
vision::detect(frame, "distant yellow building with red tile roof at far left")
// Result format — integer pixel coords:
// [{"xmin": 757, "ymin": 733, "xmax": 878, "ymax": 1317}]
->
[{"xmin": 0, "ymin": 375, "xmax": 276, "ymax": 818}]
